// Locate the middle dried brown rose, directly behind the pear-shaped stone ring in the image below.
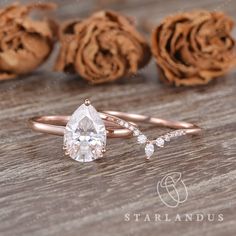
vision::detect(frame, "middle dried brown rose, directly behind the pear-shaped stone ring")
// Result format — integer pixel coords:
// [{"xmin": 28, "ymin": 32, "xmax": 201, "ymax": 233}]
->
[{"xmin": 55, "ymin": 11, "xmax": 151, "ymax": 84}]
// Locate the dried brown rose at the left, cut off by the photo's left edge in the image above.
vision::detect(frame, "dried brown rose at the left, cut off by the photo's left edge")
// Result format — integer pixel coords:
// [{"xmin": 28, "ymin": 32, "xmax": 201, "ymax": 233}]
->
[{"xmin": 0, "ymin": 3, "xmax": 55, "ymax": 80}]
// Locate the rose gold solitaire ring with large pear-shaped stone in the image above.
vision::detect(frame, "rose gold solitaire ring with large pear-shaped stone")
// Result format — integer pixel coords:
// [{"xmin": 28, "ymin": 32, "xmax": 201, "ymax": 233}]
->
[{"xmin": 29, "ymin": 99, "xmax": 135, "ymax": 162}]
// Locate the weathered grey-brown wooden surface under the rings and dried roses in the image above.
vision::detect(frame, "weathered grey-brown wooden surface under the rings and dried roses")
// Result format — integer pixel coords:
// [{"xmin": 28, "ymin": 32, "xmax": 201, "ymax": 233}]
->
[{"xmin": 0, "ymin": 0, "xmax": 236, "ymax": 236}]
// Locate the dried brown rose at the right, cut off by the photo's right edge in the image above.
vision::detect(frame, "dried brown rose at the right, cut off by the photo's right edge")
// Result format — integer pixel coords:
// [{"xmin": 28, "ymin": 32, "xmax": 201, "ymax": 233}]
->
[{"xmin": 152, "ymin": 11, "xmax": 235, "ymax": 86}]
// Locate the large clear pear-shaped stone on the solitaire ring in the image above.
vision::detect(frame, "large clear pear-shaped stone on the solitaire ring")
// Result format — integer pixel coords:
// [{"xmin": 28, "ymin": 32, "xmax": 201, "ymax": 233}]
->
[{"xmin": 64, "ymin": 104, "xmax": 106, "ymax": 162}]
